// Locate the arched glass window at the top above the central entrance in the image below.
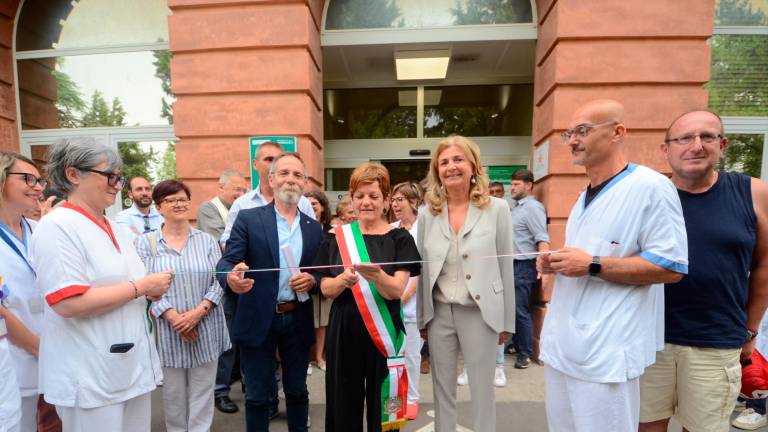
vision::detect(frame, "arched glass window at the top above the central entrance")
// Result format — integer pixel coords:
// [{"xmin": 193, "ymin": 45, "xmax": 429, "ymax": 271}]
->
[{"xmin": 326, "ymin": 0, "xmax": 533, "ymax": 30}]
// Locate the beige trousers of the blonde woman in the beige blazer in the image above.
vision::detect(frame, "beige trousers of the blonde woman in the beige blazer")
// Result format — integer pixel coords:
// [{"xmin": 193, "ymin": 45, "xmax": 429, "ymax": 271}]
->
[{"xmin": 428, "ymin": 302, "xmax": 499, "ymax": 432}]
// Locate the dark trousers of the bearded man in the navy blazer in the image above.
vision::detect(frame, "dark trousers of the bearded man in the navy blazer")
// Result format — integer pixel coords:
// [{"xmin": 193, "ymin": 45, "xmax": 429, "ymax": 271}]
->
[{"xmin": 240, "ymin": 312, "xmax": 309, "ymax": 432}]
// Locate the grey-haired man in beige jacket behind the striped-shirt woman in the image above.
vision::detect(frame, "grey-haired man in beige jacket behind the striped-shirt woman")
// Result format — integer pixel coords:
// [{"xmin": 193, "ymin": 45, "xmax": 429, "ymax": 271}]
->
[{"xmin": 197, "ymin": 170, "xmax": 248, "ymax": 414}]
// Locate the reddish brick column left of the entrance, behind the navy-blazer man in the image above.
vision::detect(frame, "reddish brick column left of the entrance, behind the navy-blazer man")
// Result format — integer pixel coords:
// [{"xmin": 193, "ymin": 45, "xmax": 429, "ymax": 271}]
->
[{"xmin": 168, "ymin": 0, "xmax": 323, "ymax": 211}]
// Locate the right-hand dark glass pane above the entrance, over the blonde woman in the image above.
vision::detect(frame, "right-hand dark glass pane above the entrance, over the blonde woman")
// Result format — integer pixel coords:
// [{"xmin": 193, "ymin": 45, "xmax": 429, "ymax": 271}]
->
[{"xmin": 424, "ymin": 84, "xmax": 533, "ymax": 137}]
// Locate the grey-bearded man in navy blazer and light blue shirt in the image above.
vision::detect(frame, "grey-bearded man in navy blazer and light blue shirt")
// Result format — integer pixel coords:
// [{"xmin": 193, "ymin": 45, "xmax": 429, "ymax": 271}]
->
[{"xmin": 216, "ymin": 153, "xmax": 323, "ymax": 432}]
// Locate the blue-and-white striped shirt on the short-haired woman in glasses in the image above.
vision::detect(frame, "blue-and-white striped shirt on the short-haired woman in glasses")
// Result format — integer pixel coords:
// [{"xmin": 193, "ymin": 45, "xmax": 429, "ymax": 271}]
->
[{"xmin": 136, "ymin": 227, "xmax": 231, "ymax": 368}]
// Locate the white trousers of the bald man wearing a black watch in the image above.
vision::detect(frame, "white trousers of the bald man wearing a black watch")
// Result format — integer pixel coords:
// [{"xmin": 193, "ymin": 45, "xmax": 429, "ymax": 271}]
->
[{"xmin": 544, "ymin": 365, "xmax": 640, "ymax": 432}]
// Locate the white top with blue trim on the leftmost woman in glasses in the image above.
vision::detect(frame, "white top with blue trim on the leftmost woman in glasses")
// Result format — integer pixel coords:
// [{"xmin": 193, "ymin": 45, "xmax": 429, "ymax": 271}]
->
[{"xmin": 0, "ymin": 218, "xmax": 44, "ymax": 397}]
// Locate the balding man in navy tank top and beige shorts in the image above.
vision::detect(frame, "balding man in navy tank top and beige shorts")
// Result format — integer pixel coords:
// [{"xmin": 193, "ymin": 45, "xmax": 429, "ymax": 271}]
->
[{"xmin": 640, "ymin": 110, "xmax": 768, "ymax": 432}]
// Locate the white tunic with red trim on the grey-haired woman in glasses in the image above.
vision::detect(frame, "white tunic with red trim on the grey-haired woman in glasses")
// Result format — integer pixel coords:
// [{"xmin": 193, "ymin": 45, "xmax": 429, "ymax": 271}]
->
[{"xmin": 31, "ymin": 203, "xmax": 162, "ymax": 408}]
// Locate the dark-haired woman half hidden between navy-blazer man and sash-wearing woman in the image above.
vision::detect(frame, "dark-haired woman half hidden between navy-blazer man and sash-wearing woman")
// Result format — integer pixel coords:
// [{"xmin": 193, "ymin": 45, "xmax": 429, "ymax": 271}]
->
[{"xmin": 304, "ymin": 191, "xmax": 333, "ymax": 375}]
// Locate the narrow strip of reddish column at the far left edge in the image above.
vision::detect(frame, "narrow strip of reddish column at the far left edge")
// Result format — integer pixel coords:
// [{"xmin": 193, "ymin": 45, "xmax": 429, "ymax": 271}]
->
[{"xmin": 0, "ymin": 0, "xmax": 19, "ymax": 152}]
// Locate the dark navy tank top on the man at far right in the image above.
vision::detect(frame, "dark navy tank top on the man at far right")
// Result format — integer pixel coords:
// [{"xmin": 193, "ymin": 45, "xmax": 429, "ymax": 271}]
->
[{"xmin": 664, "ymin": 173, "xmax": 757, "ymax": 348}]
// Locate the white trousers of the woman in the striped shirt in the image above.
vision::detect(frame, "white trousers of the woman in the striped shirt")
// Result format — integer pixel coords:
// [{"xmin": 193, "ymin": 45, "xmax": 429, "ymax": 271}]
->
[{"xmin": 163, "ymin": 361, "xmax": 217, "ymax": 432}]
